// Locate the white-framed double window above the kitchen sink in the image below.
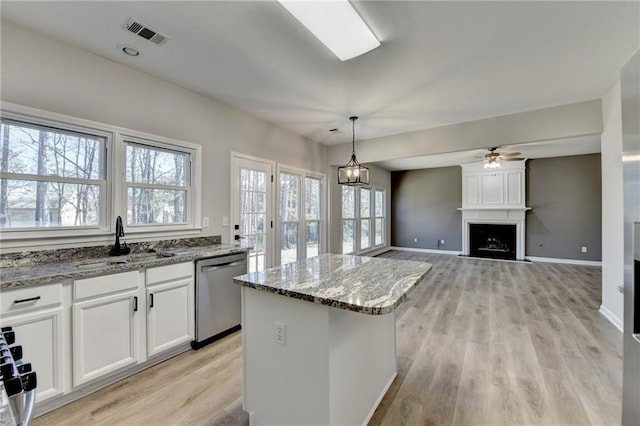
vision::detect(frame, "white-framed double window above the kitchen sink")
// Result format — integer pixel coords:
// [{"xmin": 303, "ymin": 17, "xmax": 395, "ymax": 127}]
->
[{"xmin": 0, "ymin": 102, "xmax": 202, "ymax": 249}]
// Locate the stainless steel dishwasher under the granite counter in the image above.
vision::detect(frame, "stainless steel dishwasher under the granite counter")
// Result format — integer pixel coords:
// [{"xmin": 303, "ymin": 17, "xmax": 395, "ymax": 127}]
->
[{"xmin": 191, "ymin": 253, "xmax": 247, "ymax": 349}]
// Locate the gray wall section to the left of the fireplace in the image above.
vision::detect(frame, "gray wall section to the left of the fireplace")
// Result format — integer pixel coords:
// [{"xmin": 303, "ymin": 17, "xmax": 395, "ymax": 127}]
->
[{"xmin": 391, "ymin": 166, "xmax": 462, "ymax": 251}]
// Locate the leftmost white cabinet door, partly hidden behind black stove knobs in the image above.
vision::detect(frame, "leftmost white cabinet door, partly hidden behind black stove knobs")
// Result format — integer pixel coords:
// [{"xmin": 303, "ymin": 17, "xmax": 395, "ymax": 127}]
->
[{"xmin": 2, "ymin": 308, "xmax": 64, "ymax": 403}]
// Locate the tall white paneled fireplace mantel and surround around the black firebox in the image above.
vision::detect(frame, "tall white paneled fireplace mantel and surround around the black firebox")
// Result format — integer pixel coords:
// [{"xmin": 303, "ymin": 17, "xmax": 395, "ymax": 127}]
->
[{"xmin": 458, "ymin": 160, "xmax": 531, "ymax": 260}]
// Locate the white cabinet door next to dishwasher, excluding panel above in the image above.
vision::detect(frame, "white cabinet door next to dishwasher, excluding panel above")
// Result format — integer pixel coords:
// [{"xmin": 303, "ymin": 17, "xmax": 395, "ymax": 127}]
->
[{"xmin": 147, "ymin": 277, "xmax": 195, "ymax": 356}]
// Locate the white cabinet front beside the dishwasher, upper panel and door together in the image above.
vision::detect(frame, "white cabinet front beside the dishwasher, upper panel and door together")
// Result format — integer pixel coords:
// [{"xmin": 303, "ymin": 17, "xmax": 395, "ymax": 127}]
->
[{"xmin": 146, "ymin": 262, "xmax": 195, "ymax": 357}]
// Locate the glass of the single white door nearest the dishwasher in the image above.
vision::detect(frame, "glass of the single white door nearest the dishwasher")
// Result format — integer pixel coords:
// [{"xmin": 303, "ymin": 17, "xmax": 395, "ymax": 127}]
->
[{"xmin": 239, "ymin": 168, "xmax": 268, "ymax": 272}]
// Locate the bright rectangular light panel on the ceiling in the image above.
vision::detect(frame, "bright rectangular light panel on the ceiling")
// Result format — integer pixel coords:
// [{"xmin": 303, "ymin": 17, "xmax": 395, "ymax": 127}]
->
[{"xmin": 278, "ymin": 0, "xmax": 380, "ymax": 61}]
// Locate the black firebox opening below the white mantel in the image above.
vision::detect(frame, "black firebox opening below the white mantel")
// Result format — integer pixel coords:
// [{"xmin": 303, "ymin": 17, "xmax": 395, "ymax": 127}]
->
[{"xmin": 469, "ymin": 223, "xmax": 517, "ymax": 260}]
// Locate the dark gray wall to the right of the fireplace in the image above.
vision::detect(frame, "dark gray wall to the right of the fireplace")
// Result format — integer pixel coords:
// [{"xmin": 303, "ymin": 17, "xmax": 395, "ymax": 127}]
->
[{"xmin": 526, "ymin": 154, "xmax": 602, "ymax": 261}]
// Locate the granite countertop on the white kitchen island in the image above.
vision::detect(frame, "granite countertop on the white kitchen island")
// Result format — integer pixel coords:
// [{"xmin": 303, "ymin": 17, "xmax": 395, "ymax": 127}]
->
[{"xmin": 234, "ymin": 254, "xmax": 431, "ymax": 315}]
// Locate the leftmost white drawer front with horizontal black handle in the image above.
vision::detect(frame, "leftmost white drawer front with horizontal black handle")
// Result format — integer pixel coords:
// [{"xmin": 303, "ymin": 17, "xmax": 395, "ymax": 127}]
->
[{"xmin": 0, "ymin": 283, "xmax": 62, "ymax": 316}]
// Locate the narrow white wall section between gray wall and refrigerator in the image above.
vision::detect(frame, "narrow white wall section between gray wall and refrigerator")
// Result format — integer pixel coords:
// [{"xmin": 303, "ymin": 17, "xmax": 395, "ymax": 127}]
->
[{"xmin": 600, "ymin": 82, "xmax": 624, "ymax": 330}]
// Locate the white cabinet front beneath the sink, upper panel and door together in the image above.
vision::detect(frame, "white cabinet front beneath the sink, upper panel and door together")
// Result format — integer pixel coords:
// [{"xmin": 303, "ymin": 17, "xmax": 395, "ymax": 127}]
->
[{"xmin": 72, "ymin": 271, "xmax": 144, "ymax": 386}]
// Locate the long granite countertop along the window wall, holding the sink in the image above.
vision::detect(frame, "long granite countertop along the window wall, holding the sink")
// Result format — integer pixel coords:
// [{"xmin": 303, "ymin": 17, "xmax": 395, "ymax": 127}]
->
[{"xmin": 0, "ymin": 244, "xmax": 247, "ymax": 290}]
